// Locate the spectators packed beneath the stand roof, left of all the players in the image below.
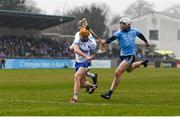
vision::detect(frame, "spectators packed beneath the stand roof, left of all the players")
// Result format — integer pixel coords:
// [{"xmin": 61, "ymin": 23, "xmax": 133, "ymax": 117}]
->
[{"xmin": 0, "ymin": 36, "xmax": 70, "ymax": 58}]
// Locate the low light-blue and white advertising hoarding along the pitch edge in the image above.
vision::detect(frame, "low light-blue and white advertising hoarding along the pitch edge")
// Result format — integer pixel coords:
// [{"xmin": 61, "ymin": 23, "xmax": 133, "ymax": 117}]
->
[{"xmin": 6, "ymin": 58, "xmax": 111, "ymax": 69}]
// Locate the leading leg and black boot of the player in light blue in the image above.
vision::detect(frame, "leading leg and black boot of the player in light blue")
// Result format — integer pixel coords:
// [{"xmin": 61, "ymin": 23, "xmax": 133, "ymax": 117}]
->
[{"xmin": 101, "ymin": 60, "xmax": 130, "ymax": 99}]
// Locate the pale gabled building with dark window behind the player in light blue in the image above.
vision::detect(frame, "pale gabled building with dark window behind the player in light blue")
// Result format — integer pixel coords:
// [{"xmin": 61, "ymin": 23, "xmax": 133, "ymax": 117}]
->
[{"xmin": 110, "ymin": 12, "xmax": 180, "ymax": 58}]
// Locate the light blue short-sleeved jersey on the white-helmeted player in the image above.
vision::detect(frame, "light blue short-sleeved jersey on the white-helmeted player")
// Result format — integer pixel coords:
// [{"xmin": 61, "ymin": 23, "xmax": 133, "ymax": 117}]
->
[{"xmin": 113, "ymin": 28, "xmax": 140, "ymax": 56}]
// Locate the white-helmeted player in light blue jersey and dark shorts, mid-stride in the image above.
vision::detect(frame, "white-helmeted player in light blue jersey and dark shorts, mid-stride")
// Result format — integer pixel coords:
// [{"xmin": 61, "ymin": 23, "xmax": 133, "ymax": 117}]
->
[{"xmin": 101, "ymin": 18, "xmax": 149, "ymax": 99}]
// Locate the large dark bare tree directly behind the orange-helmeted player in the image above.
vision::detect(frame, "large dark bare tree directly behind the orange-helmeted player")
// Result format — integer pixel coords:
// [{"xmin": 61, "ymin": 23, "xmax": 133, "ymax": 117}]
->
[{"xmin": 53, "ymin": 4, "xmax": 108, "ymax": 36}]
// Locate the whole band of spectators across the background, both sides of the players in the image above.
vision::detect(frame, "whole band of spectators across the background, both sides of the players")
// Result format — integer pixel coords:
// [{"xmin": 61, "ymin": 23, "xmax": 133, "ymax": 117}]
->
[{"xmin": 0, "ymin": 35, "xmax": 175, "ymax": 61}]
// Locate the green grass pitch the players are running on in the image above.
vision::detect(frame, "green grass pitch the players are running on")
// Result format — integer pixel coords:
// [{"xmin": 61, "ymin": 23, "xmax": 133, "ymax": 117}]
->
[{"xmin": 0, "ymin": 68, "xmax": 180, "ymax": 116}]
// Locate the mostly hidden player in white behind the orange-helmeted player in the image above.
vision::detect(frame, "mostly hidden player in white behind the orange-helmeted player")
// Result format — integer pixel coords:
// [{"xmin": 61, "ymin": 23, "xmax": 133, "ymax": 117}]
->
[{"xmin": 69, "ymin": 20, "xmax": 97, "ymax": 85}]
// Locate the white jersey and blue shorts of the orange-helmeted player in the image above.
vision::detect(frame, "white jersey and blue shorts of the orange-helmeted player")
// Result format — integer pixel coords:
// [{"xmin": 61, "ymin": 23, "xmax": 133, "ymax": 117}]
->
[{"xmin": 73, "ymin": 32, "xmax": 97, "ymax": 71}]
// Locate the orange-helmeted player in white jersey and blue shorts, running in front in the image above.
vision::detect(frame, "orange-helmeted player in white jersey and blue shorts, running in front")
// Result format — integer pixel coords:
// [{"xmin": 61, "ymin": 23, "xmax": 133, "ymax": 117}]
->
[{"xmin": 71, "ymin": 28, "xmax": 97, "ymax": 103}]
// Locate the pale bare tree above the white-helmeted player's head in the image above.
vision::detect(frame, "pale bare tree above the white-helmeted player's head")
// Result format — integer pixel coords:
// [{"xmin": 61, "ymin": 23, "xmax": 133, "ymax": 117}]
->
[{"xmin": 124, "ymin": 0, "xmax": 154, "ymax": 18}]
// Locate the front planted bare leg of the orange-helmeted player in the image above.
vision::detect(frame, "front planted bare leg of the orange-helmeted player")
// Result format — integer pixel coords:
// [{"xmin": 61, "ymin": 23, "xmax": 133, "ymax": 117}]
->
[{"xmin": 71, "ymin": 67, "xmax": 87, "ymax": 103}]
